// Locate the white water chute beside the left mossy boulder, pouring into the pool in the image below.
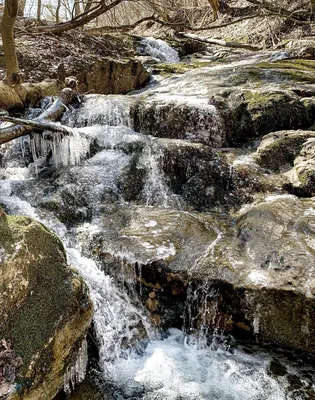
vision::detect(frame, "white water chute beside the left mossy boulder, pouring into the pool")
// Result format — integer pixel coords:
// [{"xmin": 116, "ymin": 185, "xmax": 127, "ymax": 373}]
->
[{"xmin": 67, "ymin": 244, "xmax": 151, "ymax": 378}]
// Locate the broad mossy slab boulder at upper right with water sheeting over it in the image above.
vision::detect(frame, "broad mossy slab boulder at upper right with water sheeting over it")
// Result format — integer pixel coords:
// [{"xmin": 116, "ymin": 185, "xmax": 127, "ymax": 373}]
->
[{"xmin": 134, "ymin": 57, "xmax": 315, "ymax": 147}]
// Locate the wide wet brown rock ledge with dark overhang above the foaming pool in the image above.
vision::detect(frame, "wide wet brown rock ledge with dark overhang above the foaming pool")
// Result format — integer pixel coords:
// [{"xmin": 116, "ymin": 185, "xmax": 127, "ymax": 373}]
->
[{"xmin": 86, "ymin": 195, "xmax": 315, "ymax": 353}]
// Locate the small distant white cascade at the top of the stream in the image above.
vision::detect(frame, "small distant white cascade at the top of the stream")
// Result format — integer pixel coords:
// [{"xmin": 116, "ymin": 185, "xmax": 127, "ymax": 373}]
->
[{"xmin": 141, "ymin": 37, "xmax": 179, "ymax": 64}]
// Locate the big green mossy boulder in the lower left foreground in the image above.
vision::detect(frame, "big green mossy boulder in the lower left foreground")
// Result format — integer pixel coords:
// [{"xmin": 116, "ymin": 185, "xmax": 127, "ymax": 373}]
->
[{"xmin": 0, "ymin": 210, "xmax": 93, "ymax": 400}]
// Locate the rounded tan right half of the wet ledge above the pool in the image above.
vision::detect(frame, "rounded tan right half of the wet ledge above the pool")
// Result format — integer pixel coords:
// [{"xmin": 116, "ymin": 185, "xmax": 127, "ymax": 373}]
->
[{"xmin": 196, "ymin": 195, "xmax": 315, "ymax": 353}]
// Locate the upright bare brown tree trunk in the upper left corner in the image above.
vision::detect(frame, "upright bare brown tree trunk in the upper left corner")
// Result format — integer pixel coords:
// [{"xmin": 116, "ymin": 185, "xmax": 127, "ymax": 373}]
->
[{"xmin": 1, "ymin": 0, "xmax": 21, "ymax": 85}]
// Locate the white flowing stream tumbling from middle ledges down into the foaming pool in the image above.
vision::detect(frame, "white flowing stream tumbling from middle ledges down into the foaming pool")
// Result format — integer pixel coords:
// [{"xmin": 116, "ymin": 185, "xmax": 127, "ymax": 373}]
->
[{"xmin": 0, "ymin": 50, "xmax": 314, "ymax": 400}]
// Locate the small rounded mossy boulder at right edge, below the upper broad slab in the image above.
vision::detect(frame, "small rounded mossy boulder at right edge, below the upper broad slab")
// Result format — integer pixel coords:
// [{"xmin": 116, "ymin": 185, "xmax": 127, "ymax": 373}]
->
[{"xmin": 255, "ymin": 130, "xmax": 315, "ymax": 172}]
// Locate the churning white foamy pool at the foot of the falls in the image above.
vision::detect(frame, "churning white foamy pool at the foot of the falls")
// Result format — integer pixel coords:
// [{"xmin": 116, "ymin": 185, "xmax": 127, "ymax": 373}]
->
[{"xmin": 111, "ymin": 329, "xmax": 290, "ymax": 400}]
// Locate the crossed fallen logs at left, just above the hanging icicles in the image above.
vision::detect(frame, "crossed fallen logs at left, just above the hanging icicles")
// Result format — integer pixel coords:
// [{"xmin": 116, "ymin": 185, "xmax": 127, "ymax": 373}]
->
[{"xmin": 0, "ymin": 88, "xmax": 77, "ymax": 144}]
